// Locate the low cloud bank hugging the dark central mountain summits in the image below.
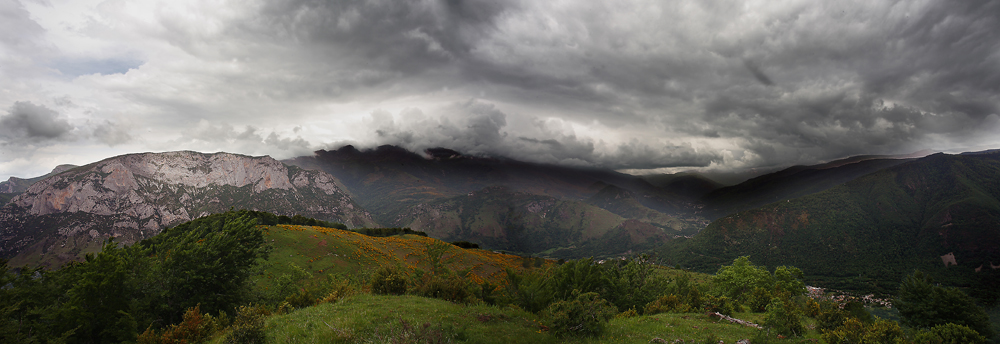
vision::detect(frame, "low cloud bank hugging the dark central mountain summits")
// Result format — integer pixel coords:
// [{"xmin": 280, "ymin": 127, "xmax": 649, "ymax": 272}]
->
[{"xmin": 356, "ymin": 100, "xmax": 722, "ymax": 169}]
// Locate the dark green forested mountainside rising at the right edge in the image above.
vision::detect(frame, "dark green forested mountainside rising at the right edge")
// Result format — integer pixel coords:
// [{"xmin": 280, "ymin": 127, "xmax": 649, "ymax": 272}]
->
[{"xmin": 663, "ymin": 154, "xmax": 1000, "ymax": 298}]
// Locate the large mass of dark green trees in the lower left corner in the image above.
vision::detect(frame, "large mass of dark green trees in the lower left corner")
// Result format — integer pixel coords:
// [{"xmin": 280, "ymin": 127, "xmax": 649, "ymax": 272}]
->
[{"xmin": 0, "ymin": 211, "xmax": 268, "ymax": 343}]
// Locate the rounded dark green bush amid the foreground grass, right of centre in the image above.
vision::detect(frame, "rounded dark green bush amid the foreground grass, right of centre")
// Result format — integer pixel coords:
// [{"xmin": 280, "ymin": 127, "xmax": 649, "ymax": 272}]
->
[{"xmin": 546, "ymin": 291, "xmax": 618, "ymax": 336}]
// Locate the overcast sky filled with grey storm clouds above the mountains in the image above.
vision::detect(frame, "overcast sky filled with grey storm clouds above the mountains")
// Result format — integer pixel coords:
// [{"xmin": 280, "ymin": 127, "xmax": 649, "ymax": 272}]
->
[{"xmin": 0, "ymin": 0, "xmax": 1000, "ymax": 180}]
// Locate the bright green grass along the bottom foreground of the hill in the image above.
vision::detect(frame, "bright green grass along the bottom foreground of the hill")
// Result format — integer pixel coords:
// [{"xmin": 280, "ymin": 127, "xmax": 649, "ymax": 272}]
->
[{"xmin": 203, "ymin": 293, "xmax": 819, "ymax": 344}]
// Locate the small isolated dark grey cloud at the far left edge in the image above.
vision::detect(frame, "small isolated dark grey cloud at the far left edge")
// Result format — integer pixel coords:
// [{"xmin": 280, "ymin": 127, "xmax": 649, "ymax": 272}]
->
[{"xmin": 0, "ymin": 102, "xmax": 73, "ymax": 144}]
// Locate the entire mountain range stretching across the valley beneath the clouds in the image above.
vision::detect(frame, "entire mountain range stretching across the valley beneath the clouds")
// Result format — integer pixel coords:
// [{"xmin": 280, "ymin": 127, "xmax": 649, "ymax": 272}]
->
[{"xmin": 0, "ymin": 146, "xmax": 1000, "ymax": 296}]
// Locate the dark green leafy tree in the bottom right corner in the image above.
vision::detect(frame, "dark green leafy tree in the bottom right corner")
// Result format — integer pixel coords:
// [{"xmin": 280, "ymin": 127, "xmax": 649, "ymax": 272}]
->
[{"xmin": 895, "ymin": 271, "xmax": 993, "ymax": 338}]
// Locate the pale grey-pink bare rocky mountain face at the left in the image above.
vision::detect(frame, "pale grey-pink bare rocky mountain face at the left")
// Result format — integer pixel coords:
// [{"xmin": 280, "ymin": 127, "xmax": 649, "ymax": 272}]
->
[{"xmin": 0, "ymin": 152, "xmax": 375, "ymax": 263}]
